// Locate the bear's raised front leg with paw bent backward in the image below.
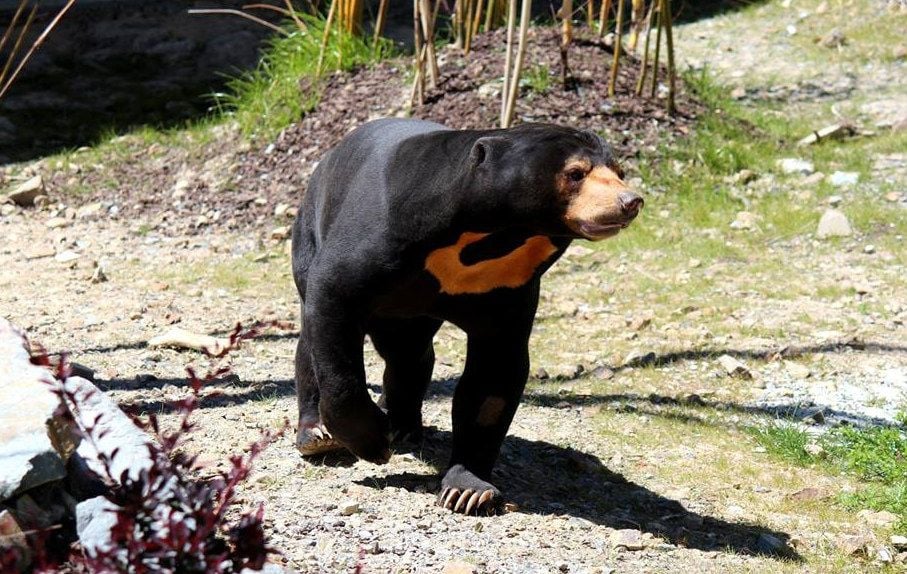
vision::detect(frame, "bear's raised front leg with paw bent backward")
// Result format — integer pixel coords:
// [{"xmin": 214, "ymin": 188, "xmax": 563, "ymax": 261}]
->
[{"xmin": 304, "ymin": 277, "xmax": 391, "ymax": 464}]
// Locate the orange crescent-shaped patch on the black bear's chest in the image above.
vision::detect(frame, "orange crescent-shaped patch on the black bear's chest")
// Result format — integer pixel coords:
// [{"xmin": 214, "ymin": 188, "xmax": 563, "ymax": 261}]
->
[{"xmin": 425, "ymin": 231, "xmax": 557, "ymax": 295}]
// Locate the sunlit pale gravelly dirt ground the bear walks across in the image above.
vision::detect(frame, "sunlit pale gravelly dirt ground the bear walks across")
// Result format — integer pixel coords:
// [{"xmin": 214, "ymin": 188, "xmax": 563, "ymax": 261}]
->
[{"xmin": 0, "ymin": 2, "xmax": 907, "ymax": 573}]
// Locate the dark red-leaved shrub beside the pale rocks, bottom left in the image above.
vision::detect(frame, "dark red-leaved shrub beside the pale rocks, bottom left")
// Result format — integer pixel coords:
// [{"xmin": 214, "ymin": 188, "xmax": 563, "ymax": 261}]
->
[{"xmin": 27, "ymin": 323, "xmax": 288, "ymax": 574}]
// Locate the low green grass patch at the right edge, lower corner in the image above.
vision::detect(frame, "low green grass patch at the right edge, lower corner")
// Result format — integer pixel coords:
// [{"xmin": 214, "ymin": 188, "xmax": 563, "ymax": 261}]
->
[{"xmin": 750, "ymin": 423, "xmax": 907, "ymax": 531}]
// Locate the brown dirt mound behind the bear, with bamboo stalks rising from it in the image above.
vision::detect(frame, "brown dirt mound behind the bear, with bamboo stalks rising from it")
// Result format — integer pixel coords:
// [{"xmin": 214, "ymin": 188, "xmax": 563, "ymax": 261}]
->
[{"xmin": 62, "ymin": 24, "xmax": 701, "ymax": 234}]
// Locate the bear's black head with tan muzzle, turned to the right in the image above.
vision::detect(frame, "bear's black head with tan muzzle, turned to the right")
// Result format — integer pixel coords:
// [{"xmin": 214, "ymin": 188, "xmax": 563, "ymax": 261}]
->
[{"xmin": 470, "ymin": 124, "xmax": 643, "ymax": 241}]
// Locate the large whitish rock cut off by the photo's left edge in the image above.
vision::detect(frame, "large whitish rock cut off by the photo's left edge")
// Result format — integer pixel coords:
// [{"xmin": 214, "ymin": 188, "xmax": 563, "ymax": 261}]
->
[{"xmin": 0, "ymin": 318, "xmax": 79, "ymax": 500}]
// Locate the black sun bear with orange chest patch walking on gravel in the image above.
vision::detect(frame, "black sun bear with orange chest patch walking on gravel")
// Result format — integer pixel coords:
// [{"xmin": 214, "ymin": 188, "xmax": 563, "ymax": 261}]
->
[{"xmin": 292, "ymin": 118, "xmax": 643, "ymax": 514}]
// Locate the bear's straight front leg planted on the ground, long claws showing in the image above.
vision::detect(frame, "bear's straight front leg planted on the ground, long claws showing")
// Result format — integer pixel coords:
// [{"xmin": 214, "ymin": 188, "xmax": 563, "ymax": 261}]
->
[{"xmin": 438, "ymin": 316, "xmax": 535, "ymax": 514}]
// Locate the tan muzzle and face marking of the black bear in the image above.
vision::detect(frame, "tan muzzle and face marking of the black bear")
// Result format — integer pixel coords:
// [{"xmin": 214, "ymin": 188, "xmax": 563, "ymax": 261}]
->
[{"xmin": 558, "ymin": 160, "xmax": 628, "ymax": 240}]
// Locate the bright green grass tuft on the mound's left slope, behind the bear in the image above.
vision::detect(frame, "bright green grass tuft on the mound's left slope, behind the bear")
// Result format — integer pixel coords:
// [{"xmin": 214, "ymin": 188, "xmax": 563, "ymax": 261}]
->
[{"xmin": 217, "ymin": 15, "xmax": 391, "ymax": 137}]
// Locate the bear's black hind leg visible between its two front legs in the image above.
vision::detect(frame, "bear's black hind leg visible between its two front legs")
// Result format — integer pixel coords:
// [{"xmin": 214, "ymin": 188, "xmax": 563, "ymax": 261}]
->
[{"xmin": 368, "ymin": 317, "xmax": 441, "ymax": 442}]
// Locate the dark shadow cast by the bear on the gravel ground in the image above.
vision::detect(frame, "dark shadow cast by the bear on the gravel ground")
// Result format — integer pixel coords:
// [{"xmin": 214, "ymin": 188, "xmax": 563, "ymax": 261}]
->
[{"xmin": 359, "ymin": 428, "xmax": 801, "ymax": 561}]
